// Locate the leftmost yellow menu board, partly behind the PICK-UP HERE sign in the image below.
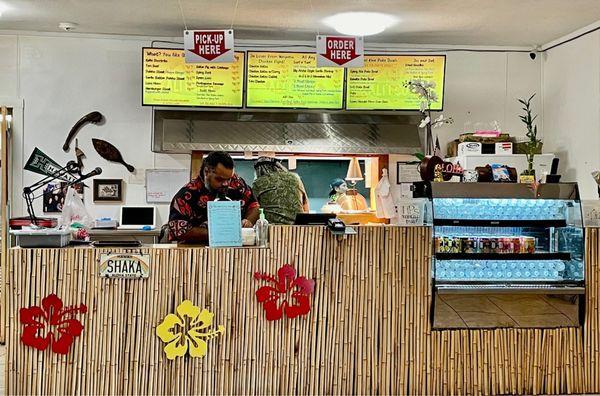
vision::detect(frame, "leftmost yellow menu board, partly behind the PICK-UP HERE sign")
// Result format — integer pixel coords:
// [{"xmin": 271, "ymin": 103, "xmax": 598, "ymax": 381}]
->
[{"xmin": 142, "ymin": 48, "xmax": 244, "ymax": 107}]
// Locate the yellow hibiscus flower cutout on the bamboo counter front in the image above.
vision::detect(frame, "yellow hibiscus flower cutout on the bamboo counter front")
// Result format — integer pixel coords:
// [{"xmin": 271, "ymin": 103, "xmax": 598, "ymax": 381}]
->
[{"xmin": 156, "ymin": 300, "xmax": 225, "ymax": 360}]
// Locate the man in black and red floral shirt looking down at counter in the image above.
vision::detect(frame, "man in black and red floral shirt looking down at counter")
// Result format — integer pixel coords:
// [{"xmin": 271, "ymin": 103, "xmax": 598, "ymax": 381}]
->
[{"xmin": 168, "ymin": 151, "xmax": 259, "ymax": 242}]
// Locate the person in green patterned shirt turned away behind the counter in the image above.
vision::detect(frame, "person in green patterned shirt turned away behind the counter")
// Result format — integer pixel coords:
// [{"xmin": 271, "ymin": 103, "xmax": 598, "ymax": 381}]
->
[{"xmin": 252, "ymin": 157, "xmax": 309, "ymax": 224}]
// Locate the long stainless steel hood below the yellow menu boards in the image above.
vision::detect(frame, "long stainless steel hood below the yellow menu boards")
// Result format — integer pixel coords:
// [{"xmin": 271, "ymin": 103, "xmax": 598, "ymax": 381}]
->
[{"xmin": 152, "ymin": 109, "xmax": 421, "ymax": 154}]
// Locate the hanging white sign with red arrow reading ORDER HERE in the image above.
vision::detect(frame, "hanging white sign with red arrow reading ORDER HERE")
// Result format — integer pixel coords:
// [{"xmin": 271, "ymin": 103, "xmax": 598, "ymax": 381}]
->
[{"xmin": 317, "ymin": 36, "xmax": 365, "ymax": 67}]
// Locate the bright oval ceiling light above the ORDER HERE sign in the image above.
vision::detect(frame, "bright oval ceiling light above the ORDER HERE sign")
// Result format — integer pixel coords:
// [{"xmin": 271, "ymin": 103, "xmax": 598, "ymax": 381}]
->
[{"xmin": 323, "ymin": 12, "xmax": 398, "ymax": 36}]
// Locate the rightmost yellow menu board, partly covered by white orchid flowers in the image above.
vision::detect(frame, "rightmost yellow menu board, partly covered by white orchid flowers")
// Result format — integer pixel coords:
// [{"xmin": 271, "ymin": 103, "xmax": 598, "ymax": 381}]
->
[{"xmin": 346, "ymin": 55, "xmax": 446, "ymax": 110}]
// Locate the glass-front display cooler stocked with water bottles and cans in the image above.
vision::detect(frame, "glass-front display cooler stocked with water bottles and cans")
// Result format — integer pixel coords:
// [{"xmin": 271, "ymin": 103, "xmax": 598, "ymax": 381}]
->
[{"xmin": 431, "ymin": 183, "xmax": 585, "ymax": 328}]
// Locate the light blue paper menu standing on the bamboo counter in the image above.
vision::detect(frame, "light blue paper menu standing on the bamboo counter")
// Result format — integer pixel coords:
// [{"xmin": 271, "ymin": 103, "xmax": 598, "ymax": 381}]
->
[{"xmin": 208, "ymin": 201, "xmax": 242, "ymax": 247}]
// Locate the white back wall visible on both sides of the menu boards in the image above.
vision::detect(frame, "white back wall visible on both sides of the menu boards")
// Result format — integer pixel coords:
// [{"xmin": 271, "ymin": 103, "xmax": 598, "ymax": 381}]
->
[{"xmin": 0, "ymin": 34, "xmax": 541, "ymax": 222}]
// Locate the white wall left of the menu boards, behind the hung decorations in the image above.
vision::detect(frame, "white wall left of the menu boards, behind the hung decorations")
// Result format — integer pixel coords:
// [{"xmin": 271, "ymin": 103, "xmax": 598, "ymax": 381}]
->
[{"xmin": 0, "ymin": 36, "xmax": 190, "ymax": 226}]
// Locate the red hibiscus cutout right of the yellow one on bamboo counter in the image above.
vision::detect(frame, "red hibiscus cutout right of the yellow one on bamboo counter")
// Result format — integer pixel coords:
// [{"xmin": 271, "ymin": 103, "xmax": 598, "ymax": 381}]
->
[{"xmin": 254, "ymin": 264, "xmax": 315, "ymax": 320}]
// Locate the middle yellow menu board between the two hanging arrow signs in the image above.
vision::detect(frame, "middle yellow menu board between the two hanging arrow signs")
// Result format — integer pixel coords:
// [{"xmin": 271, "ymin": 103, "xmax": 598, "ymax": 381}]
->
[{"xmin": 246, "ymin": 51, "xmax": 344, "ymax": 109}]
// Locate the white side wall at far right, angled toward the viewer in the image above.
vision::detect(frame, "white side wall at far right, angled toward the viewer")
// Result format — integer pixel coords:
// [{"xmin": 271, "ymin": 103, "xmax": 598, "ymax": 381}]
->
[{"xmin": 543, "ymin": 28, "xmax": 600, "ymax": 199}]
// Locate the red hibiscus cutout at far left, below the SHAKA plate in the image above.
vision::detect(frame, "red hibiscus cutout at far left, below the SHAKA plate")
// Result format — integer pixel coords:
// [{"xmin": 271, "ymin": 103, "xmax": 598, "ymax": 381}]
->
[{"xmin": 19, "ymin": 294, "xmax": 87, "ymax": 355}]
